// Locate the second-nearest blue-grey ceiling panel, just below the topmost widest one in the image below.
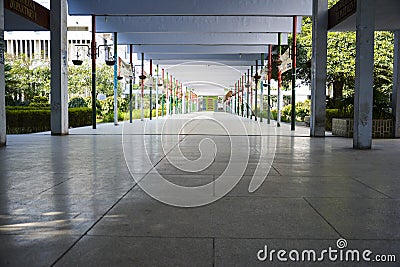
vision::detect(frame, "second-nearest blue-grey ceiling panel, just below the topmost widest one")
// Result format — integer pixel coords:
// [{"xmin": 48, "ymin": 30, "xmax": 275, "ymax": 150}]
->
[{"xmin": 96, "ymin": 15, "xmax": 301, "ymax": 33}]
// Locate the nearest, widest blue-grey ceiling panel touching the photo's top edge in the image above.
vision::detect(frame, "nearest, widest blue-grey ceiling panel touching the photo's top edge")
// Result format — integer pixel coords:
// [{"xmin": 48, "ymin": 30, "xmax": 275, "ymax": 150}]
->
[{"xmin": 68, "ymin": 0, "xmax": 312, "ymax": 16}]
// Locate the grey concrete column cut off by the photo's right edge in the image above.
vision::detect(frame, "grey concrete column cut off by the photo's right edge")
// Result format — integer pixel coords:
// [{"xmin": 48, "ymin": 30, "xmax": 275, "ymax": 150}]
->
[{"xmin": 392, "ymin": 30, "xmax": 400, "ymax": 138}]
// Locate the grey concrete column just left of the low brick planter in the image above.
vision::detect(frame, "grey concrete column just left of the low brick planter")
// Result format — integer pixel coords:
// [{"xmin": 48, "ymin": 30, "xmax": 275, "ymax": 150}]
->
[{"xmin": 310, "ymin": 0, "xmax": 328, "ymax": 137}]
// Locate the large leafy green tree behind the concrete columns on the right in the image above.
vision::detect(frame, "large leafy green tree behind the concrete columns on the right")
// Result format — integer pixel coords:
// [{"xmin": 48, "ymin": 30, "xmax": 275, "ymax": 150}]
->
[{"xmin": 283, "ymin": 0, "xmax": 394, "ymax": 99}]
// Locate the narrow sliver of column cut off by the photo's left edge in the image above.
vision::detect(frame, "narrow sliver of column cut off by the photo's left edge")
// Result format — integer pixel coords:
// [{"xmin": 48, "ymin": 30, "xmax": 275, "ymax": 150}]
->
[{"xmin": 0, "ymin": 1, "xmax": 6, "ymax": 146}]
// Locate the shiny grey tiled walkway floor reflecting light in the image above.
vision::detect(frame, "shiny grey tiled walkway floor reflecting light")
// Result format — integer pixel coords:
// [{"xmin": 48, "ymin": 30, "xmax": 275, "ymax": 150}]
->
[{"xmin": 0, "ymin": 113, "xmax": 400, "ymax": 266}]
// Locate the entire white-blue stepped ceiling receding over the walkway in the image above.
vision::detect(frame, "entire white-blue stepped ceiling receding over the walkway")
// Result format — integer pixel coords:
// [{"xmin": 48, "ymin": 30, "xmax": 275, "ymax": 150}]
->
[{"xmin": 68, "ymin": 0, "xmax": 312, "ymax": 95}]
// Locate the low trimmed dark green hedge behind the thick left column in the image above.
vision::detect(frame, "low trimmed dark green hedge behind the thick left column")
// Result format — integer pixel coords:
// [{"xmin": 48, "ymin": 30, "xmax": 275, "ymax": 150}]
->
[{"xmin": 6, "ymin": 107, "xmax": 92, "ymax": 134}]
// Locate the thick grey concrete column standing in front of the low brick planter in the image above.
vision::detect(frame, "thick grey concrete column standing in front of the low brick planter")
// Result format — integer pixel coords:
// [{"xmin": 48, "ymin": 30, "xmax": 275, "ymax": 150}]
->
[{"xmin": 353, "ymin": 0, "xmax": 375, "ymax": 149}]
